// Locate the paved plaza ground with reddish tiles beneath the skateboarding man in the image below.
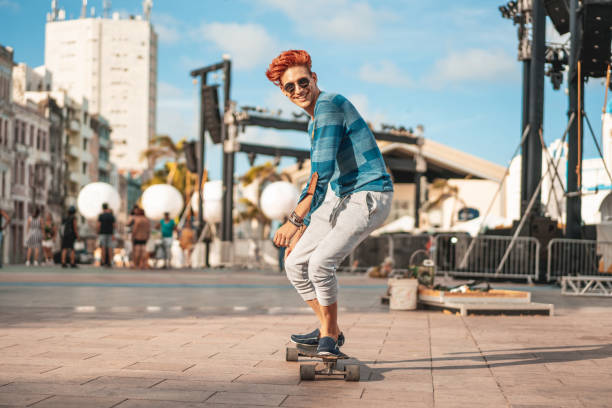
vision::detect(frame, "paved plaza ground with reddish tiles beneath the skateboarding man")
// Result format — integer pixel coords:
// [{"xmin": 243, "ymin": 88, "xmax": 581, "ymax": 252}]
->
[{"xmin": 0, "ymin": 266, "xmax": 612, "ymax": 408}]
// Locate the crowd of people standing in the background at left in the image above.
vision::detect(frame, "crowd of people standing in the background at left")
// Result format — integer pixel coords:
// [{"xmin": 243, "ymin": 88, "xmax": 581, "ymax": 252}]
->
[{"xmin": 0, "ymin": 203, "xmax": 196, "ymax": 269}]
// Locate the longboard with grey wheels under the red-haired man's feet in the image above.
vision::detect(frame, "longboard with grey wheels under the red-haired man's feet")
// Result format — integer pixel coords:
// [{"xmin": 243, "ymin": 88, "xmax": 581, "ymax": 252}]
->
[{"xmin": 285, "ymin": 344, "xmax": 360, "ymax": 381}]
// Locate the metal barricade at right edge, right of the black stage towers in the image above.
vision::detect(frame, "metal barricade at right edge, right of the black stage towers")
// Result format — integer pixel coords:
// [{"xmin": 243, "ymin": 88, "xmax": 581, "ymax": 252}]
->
[{"xmin": 546, "ymin": 238, "xmax": 612, "ymax": 282}]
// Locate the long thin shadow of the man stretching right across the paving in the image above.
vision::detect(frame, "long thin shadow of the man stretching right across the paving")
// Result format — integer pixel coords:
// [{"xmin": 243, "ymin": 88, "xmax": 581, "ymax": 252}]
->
[{"xmin": 338, "ymin": 344, "xmax": 612, "ymax": 381}]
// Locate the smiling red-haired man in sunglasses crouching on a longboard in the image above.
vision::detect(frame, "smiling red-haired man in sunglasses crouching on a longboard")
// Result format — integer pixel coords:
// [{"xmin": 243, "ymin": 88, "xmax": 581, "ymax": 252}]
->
[{"xmin": 266, "ymin": 50, "xmax": 393, "ymax": 355}]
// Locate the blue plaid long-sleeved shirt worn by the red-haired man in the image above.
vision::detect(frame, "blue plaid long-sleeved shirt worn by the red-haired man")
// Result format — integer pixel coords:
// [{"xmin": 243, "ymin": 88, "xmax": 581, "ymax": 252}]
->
[{"xmin": 299, "ymin": 92, "xmax": 393, "ymax": 225}]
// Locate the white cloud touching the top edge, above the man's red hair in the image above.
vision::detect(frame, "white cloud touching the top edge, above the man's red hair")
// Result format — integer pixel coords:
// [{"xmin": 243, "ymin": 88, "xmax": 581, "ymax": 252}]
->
[{"xmin": 260, "ymin": 0, "xmax": 396, "ymax": 42}]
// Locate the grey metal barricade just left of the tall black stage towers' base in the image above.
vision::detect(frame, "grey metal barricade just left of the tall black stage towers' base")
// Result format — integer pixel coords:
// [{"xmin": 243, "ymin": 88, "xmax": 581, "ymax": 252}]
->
[{"xmin": 434, "ymin": 234, "xmax": 540, "ymax": 281}]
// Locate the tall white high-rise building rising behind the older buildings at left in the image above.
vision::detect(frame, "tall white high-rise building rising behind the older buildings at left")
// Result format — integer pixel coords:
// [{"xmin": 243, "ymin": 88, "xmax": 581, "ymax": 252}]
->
[{"xmin": 45, "ymin": 1, "xmax": 157, "ymax": 170}]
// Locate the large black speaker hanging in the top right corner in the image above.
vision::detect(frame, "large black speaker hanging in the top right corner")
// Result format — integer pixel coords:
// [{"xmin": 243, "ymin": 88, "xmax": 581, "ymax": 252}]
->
[{"xmin": 580, "ymin": 0, "xmax": 612, "ymax": 78}]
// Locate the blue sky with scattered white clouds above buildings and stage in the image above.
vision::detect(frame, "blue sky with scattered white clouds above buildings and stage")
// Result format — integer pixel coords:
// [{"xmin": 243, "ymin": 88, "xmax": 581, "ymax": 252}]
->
[{"xmin": 0, "ymin": 0, "xmax": 604, "ymax": 179}]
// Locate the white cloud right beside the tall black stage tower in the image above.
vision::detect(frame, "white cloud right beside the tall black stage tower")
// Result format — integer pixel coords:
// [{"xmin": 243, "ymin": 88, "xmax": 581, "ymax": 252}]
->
[{"xmin": 426, "ymin": 49, "xmax": 518, "ymax": 86}]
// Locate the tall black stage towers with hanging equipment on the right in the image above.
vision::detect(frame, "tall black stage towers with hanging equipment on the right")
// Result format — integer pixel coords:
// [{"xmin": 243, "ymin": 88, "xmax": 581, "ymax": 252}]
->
[{"xmin": 499, "ymin": 0, "xmax": 612, "ymax": 241}]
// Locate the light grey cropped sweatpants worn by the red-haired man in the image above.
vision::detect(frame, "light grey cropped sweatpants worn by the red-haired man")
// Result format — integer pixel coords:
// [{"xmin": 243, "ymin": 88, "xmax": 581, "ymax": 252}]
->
[{"xmin": 285, "ymin": 191, "xmax": 393, "ymax": 306}]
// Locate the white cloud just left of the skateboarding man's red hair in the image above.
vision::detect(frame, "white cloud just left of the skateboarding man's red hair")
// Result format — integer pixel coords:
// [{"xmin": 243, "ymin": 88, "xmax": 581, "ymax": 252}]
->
[{"xmin": 196, "ymin": 22, "xmax": 279, "ymax": 69}]
